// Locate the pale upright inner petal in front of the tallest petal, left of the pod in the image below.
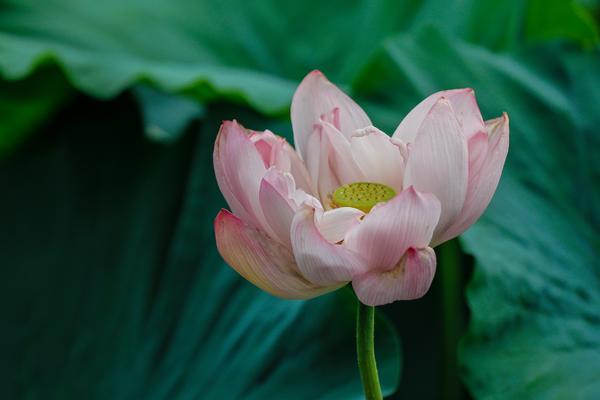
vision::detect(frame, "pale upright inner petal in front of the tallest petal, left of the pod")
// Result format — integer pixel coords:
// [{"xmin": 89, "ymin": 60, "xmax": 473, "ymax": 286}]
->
[{"xmin": 305, "ymin": 122, "xmax": 363, "ymax": 208}]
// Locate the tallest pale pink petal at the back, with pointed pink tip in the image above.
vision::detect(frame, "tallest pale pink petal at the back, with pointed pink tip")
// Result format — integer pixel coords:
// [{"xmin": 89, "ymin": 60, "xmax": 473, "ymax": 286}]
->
[{"xmin": 291, "ymin": 71, "xmax": 371, "ymax": 159}]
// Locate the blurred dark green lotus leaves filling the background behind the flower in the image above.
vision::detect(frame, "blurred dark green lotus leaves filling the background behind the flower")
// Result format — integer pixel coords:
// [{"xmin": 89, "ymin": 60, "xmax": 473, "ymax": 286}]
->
[{"xmin": 0, "ymin": 0, "xmax": 600, "ymax": 399}]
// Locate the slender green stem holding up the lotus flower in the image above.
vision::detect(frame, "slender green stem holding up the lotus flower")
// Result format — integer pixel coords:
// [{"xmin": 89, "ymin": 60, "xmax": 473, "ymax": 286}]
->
[{"xmin": 356, "ymin": 301, "xmax": 383, "ymax": 400}]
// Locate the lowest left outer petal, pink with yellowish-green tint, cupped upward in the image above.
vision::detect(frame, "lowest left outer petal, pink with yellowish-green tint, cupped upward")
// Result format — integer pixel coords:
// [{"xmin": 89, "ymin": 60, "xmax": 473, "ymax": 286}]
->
[{"xmin": 215, "ymin": 210, "xmax": 337, "ymax": 299}]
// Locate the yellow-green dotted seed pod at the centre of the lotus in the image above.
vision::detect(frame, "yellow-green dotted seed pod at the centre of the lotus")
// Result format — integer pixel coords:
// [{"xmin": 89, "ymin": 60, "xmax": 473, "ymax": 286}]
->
[{"xmin": 333, "ymin": 182, "xmax": 396, "ymax": 212}]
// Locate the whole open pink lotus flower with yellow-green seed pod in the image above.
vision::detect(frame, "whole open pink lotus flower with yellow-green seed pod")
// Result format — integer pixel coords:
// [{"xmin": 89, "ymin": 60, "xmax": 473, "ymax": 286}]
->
[{"xmin": 214, "ymin": 71, "xmax": 508, "ymax": 305}]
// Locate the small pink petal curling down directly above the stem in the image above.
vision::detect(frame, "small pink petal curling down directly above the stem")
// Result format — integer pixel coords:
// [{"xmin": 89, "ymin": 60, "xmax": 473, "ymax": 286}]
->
[{"xmin": 352, "ymin": 247, "xmax": 436, "ymax": 306}]
